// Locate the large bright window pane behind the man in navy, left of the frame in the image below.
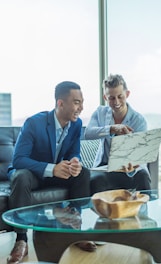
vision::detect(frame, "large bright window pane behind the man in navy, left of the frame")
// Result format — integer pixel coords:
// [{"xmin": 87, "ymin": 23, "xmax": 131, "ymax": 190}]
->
[{"xmin": 0, "ymin": 0, "xmax": 100, "ymax": 125}]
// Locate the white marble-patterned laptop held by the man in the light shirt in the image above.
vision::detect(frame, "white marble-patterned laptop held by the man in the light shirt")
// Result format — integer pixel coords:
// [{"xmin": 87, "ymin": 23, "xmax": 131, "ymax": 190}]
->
[{"xmin": 91, "ymin": 128, "xmax": 161, "ymax": 172}]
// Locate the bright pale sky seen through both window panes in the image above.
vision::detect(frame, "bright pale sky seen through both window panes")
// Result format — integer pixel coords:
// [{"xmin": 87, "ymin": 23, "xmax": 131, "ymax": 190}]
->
[{"xmin": 0, "ymin": 0, "xmax": 161, "ymax": 177}]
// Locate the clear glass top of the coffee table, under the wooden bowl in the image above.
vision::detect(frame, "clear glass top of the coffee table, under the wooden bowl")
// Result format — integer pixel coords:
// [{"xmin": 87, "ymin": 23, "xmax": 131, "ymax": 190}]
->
[{"xmin": 2, "ymin": 190, "xmax": 161, "ymax": 233}]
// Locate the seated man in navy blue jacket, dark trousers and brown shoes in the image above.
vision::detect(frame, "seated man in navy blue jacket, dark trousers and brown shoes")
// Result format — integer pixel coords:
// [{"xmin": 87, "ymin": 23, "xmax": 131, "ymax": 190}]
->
[{"xmin": 7, "ymin": 81, "xmax": 90, "ymax": 264}]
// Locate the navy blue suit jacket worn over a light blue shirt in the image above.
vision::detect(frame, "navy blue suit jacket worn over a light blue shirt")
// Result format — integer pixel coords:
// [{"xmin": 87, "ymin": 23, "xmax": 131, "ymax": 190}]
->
[{"xmin": 13, "ymin": 110, "xmax": 82, "ymax": 177}]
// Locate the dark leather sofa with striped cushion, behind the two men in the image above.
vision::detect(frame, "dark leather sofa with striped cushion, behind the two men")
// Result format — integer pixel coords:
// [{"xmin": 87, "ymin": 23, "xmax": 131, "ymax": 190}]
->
[{"xmin": 0, "ymin": 127, "xmax": 159, "ymax": 231}]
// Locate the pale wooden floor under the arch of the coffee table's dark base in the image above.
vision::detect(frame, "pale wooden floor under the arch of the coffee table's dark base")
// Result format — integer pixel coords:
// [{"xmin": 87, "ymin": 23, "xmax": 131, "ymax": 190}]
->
[{"xmin": 59, "ymin": 243, "xmax": 154, "ymax": 264}]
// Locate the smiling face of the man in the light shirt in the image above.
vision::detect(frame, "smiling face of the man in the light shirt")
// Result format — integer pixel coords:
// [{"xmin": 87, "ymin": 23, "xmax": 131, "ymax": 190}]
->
[{"xmin": 104, "ymin": 84, "xmax": 130, "ymax": 115}]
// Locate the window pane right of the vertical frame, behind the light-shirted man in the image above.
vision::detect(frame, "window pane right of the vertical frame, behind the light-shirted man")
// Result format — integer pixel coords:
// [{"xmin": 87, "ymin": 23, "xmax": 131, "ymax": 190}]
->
[{"xmin": 107, "ymin": 0, "xmax": 161, "ymax": 128}]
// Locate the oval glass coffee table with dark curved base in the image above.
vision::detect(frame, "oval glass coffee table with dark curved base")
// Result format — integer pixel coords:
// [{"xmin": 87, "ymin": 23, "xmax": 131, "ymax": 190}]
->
[{"xmin": 2, "ymin": 190, "xmax": 161, "ymax": 262}]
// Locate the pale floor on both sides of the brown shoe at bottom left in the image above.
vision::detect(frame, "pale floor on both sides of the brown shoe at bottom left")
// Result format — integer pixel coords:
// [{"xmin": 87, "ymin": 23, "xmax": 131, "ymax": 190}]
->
[{"xmin": 0, "ymin": 230, "xmax": 37, "ymax": 264}]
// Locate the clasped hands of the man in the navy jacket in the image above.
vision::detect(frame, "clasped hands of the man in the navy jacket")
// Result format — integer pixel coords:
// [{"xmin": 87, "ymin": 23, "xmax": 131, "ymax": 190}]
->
[{"xmin": 53, "ymin": 157, "xmax": 82, "ymax": 179}]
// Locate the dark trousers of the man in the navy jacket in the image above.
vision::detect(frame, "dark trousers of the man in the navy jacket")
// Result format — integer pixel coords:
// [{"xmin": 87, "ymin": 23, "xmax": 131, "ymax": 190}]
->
[{"xmin": 9, "ymin": 167, "xmax": 90, "ymax": 233}]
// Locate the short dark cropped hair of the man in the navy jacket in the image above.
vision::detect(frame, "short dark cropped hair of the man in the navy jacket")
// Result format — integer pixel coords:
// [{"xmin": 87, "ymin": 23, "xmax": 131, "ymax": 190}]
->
[{"xmin": 55, "ymin": 81, "xmax": 81, "ymax": 101}]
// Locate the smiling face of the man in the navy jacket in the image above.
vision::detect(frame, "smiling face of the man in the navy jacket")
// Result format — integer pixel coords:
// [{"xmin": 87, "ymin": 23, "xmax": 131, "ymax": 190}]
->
[{"xmin": 56, "ymin": 89, "xmax": 83, "ymax": 127}]
